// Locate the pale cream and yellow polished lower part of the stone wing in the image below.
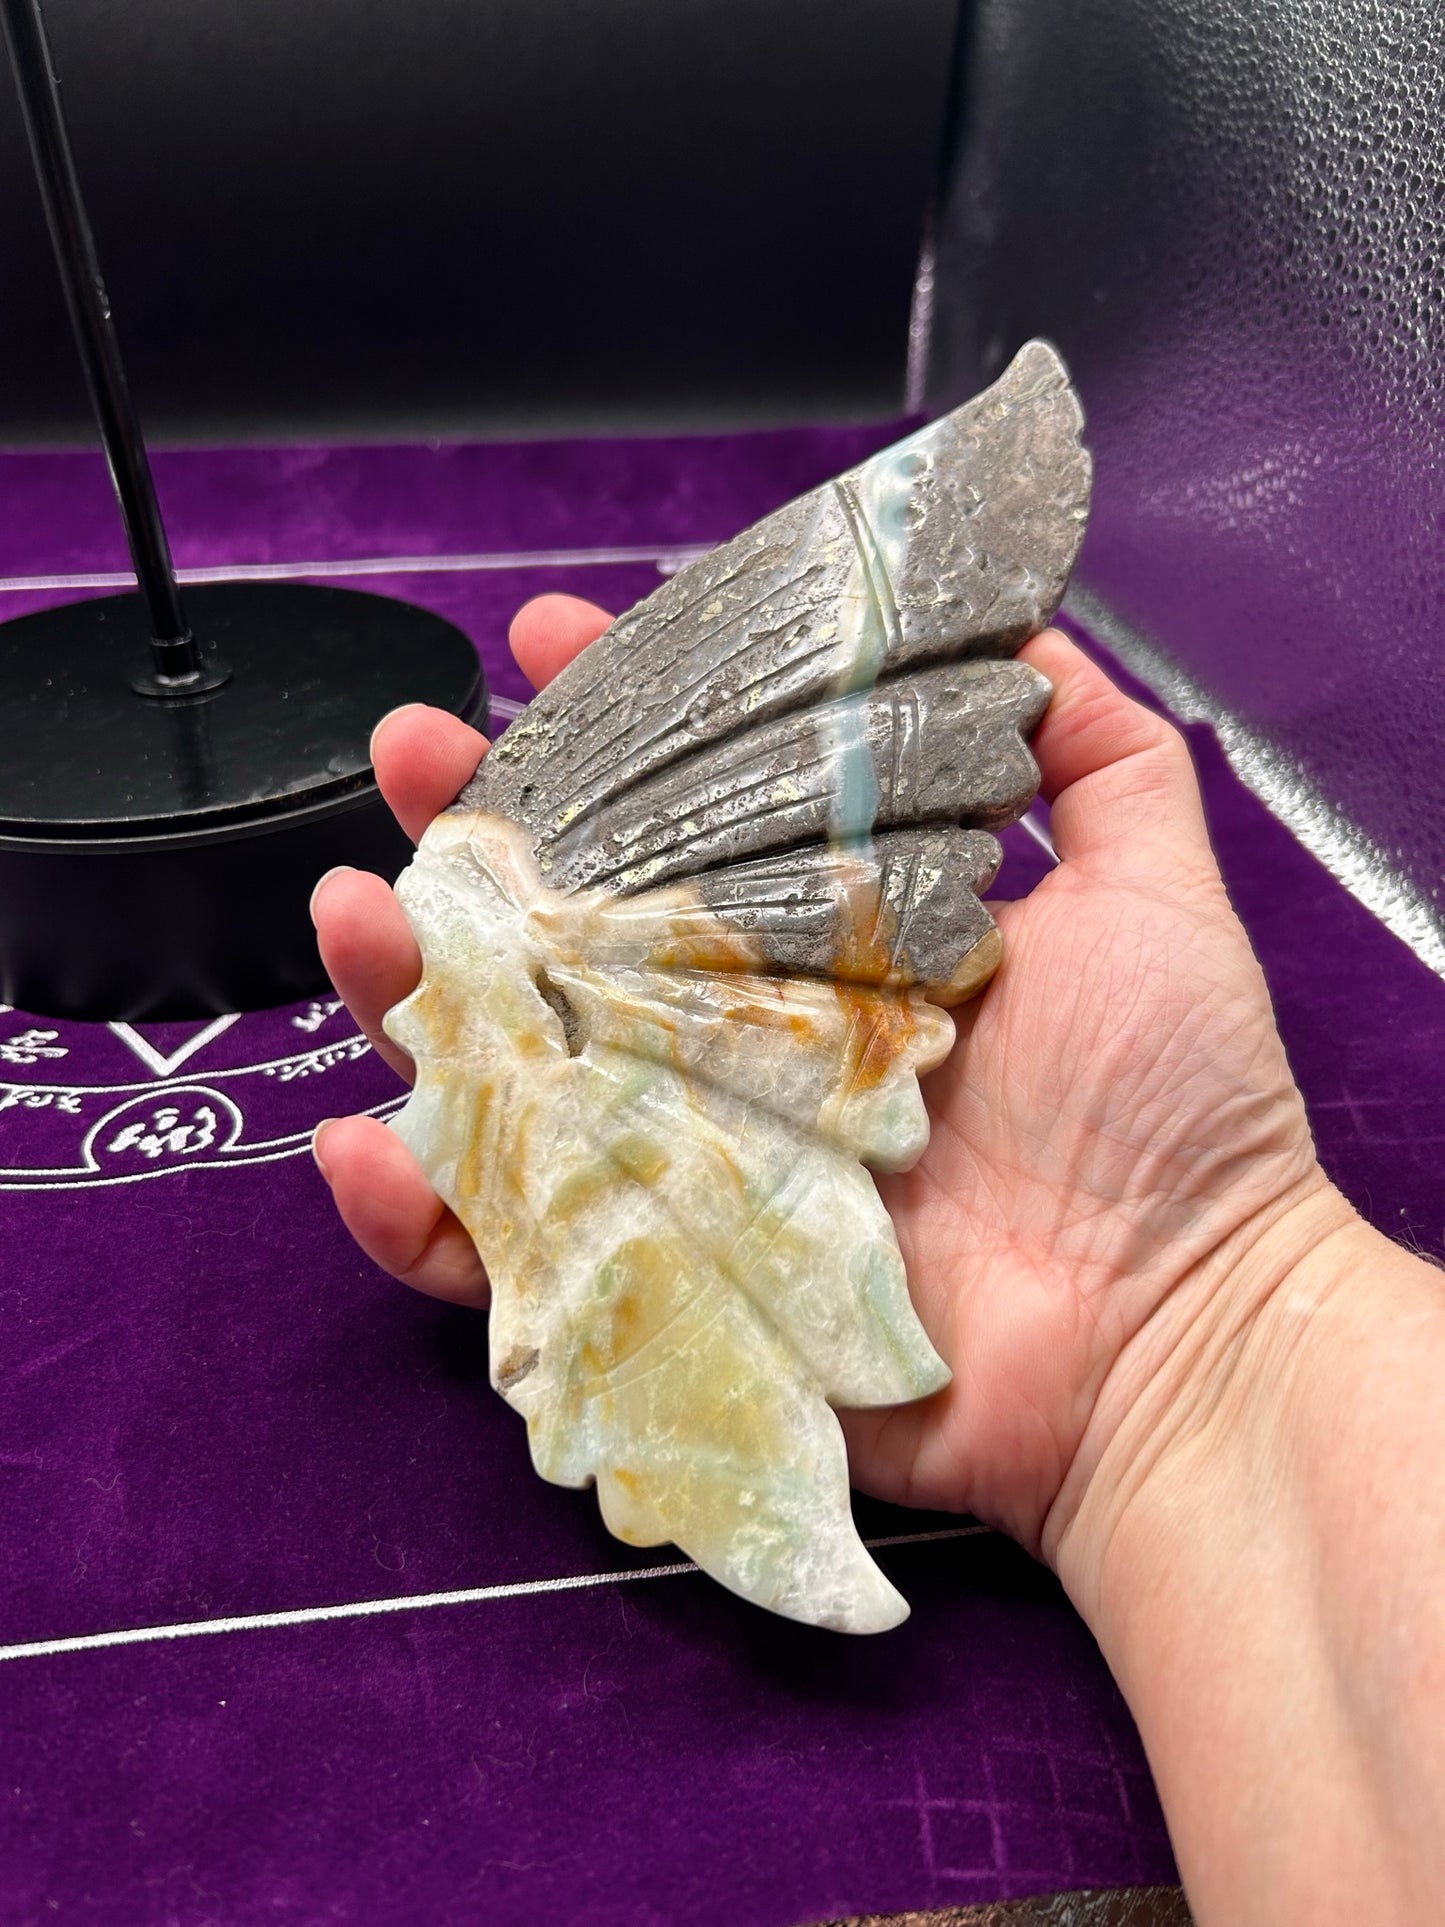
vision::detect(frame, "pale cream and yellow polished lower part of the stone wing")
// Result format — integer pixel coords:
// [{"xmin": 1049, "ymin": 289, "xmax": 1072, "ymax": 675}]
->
[{"xmin": 387, "ymin": 815, "xmax": 954, "ymax": 1632}]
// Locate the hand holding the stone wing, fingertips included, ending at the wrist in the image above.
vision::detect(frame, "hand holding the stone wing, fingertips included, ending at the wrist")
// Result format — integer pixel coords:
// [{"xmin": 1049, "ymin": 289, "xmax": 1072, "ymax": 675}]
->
[{"xmin": 314, "ymin": 595, "xmax": 1343, "ymax": 1580}]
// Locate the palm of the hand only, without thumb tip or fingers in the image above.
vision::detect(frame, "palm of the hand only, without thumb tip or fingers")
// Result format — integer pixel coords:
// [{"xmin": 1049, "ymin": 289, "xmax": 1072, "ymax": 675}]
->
[{"xmin": 846, "ymin": 844, "xmax": 1312, "ymax": 1549}]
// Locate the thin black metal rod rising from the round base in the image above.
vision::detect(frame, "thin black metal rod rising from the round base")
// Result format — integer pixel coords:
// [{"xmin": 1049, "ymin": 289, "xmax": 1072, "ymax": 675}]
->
[{"xmin": 0, "ymin": 0, "xmax": 200, "ymax": 682}]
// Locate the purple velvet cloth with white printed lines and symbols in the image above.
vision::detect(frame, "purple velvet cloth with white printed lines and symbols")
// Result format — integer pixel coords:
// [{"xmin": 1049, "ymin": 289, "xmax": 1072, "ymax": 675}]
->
[{"xmin": 0, "ymin": 430, "xmax": 1445, "ymax": 1927}]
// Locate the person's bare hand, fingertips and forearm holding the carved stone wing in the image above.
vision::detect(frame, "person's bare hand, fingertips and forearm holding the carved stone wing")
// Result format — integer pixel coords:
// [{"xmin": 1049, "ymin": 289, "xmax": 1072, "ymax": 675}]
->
[{"xmin": 312, "ymin": 595, "xmax": 1445, "ymax": 1927}]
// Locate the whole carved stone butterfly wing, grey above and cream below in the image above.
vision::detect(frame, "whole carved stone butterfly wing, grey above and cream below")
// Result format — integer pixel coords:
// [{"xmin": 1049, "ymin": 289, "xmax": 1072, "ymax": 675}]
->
[{"xmin": 387, "ymin": 341, "xmax": 1090, "ymax": 1632}]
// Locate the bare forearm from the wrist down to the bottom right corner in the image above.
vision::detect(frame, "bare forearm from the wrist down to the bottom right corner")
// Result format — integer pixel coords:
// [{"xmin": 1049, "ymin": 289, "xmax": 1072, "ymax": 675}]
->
[{"xmin": 1060, "ymin": 1201, "xmax": 1445, "ymax": 1927}]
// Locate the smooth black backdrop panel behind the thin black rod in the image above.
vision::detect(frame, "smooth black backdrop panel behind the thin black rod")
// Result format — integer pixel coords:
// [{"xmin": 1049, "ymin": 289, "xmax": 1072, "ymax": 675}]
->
[{"xmin": 0, "ymin": 0, "xmax": 958, "ymax": 443}]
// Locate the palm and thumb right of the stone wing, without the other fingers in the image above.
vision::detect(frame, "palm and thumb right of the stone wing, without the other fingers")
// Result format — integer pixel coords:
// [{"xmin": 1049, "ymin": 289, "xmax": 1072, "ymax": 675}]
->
[{"xmin": 840, "ymin": 630, "xmax": 1353, "ymax": 1594}]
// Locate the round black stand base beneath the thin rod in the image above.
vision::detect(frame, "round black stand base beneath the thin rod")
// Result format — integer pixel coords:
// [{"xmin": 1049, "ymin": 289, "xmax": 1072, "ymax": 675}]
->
[{"xmin": 0, "ymin": 582, "xmax": 487, "ymax": 1019}]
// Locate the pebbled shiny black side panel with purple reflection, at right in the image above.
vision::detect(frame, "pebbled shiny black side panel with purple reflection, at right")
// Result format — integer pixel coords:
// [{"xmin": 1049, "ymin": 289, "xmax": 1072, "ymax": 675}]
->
[{"xmin": 933, "ymin": 0, "xmax": 1445, "ymax": 906}]
